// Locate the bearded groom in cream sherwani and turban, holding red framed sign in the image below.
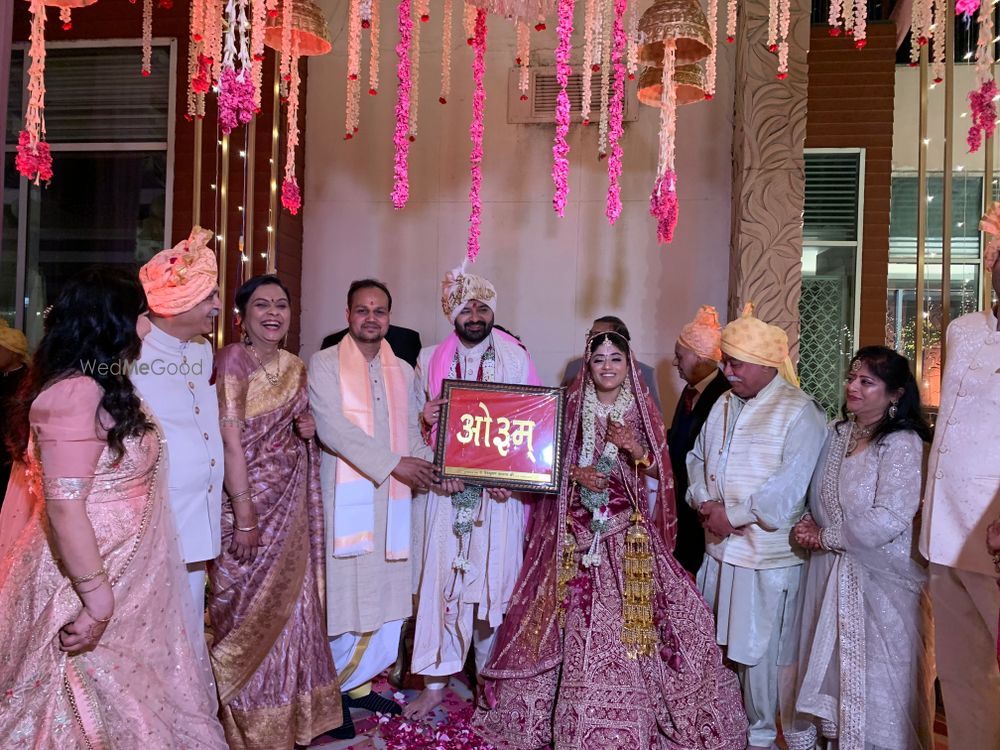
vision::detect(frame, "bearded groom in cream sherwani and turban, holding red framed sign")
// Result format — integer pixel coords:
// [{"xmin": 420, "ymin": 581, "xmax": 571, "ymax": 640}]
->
[{"xmin": 404, "ymin": 270, "xmax": 541, "ymax": 717}]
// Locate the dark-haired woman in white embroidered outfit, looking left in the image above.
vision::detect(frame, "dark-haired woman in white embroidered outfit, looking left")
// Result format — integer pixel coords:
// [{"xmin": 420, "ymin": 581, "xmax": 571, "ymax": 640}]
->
[{"xmin": 783, "ymin": 347, "xmax": 934, "ymax": 750}]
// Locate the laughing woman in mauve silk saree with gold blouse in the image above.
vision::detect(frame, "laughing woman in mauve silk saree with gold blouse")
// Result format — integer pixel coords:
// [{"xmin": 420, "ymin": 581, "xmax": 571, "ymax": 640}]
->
[{"xmin": 208, "ymin": 276, "xmax": 343, "ymax": 750}]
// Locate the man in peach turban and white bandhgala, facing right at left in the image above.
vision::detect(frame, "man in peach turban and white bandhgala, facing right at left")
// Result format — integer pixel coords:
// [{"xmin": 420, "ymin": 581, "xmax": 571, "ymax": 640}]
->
[{"xmin": 132, "ymin": 227, "xmax": 223, "ymax": 656}]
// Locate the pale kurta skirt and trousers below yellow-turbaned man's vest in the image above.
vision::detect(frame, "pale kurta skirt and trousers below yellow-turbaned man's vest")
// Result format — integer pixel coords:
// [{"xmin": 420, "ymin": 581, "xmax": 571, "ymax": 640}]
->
[{"xmin": 697, "ymin": 555, "xmax": 802, "ymax": 747}]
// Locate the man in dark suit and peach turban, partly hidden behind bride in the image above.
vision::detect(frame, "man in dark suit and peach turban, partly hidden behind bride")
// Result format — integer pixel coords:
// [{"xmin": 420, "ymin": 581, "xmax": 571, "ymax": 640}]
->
[{"xmin": 667, "ymin": 305, "xmax": 729, "ymax": 575}]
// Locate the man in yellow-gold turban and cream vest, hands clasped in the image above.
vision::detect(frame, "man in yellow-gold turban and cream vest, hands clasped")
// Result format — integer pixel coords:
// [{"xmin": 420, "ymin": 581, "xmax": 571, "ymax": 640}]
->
[{"xmin": 687, "ymin": 305, "xmax": 826, "ymax": 750}]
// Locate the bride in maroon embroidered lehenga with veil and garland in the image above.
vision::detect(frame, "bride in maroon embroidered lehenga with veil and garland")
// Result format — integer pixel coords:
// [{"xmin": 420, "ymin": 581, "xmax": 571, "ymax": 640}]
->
[{"xmin": 473, "ymin": 333, "xmax": 747, "ymax": 750}]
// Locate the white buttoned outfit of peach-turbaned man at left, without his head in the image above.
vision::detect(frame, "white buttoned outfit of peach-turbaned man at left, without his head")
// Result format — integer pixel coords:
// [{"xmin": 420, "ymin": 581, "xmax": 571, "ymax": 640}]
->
[{"xmin": 131, "ymin": 323, "xmax": 224, "ymax": 631}]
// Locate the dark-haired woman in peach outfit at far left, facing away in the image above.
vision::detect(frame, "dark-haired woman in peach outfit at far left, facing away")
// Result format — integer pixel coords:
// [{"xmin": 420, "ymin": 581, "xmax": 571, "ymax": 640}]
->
[{"xmin": 0, "ymin": 270, "xmax": 226, "ymax": 750}]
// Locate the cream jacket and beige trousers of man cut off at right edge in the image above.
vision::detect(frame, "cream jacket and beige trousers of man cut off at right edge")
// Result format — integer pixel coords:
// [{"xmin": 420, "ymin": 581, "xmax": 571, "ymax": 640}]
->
[{"xmin": 920, "ymin": 310, "xmax": 1000, "ymax": 750}]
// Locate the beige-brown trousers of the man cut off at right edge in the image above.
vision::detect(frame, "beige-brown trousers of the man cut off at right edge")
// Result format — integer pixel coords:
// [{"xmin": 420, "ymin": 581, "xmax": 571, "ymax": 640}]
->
[{"xmin": 930, "ymin": 563, "xmax": 1000, "ymax": 750}]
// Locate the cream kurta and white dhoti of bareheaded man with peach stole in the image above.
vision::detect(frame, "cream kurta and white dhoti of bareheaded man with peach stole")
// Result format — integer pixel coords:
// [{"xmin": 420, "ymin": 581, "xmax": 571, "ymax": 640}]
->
[{"xmin": 309, "ymin": 345, "xmax": 431, "ymax": 691}]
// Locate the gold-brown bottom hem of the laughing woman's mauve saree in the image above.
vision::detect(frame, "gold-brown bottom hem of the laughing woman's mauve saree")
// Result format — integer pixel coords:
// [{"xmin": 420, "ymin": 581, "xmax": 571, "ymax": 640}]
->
[{"xmin": 219, "ymin": 682, "xmax": 344, "ymax": 750}]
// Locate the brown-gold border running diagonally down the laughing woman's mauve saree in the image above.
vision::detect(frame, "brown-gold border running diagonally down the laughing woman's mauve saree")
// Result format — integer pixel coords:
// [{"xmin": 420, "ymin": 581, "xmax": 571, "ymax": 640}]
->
[{"xmin": 209, "ymin": 484, "xmax": 309, "ymax": 706}]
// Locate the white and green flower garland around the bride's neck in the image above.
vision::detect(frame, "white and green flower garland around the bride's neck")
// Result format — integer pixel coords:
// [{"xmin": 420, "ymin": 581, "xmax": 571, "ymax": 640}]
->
[{"xmin": 580, "ymin": 378, "xmax": 635, "ymax": 568}]
